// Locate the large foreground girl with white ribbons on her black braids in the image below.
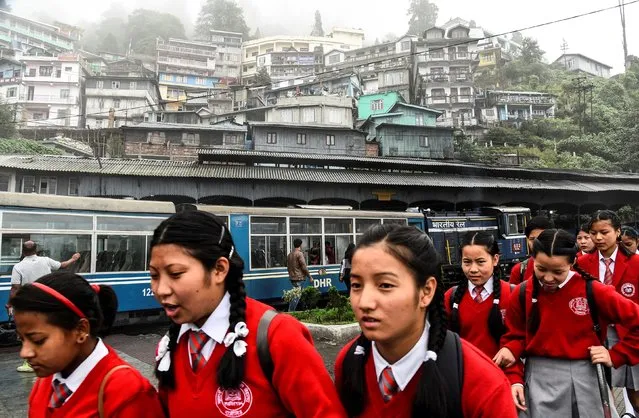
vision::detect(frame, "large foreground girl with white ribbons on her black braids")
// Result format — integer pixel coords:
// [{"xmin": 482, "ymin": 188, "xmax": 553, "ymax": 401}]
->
[{"xmin": 149, "ymin": 210, "xmax": 344, "ymax": 418}]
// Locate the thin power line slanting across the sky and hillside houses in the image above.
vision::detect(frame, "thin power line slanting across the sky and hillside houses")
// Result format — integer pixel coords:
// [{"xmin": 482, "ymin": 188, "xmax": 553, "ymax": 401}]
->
[{"xmin": 0, "ymin": 0, "xmax": 639, "ymax": 127}]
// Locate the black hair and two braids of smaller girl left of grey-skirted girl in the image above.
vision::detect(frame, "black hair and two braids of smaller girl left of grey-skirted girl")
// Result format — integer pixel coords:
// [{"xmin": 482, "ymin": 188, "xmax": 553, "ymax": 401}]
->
[{"xmin": 449, "ymin": 231, "xmax": 506, "ymax": 344}]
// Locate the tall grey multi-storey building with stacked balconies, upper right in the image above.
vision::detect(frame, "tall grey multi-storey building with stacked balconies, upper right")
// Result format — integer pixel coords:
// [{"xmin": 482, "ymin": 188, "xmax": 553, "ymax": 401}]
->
[{"xmin": 416, "ymin": 22, "xmax": 483, "ymax": 127}]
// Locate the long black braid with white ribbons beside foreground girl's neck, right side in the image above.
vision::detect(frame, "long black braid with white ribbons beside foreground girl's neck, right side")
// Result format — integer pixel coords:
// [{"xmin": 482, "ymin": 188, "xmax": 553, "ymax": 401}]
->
[{"xmin": 217, "ymin": 261, "xmax": 250, "ymax": 389}]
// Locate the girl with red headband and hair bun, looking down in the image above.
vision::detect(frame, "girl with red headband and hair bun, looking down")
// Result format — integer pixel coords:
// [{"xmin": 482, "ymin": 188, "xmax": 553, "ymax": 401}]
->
[{"xmin": 11, "ymin": 272, "xmax": 164, "ymax": 418}]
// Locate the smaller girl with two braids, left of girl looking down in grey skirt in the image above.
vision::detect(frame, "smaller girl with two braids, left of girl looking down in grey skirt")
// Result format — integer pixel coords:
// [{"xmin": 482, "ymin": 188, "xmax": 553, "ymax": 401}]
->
[{"xmin": 444, "ymin": 231, "xmax": 515, "ymax": 366}]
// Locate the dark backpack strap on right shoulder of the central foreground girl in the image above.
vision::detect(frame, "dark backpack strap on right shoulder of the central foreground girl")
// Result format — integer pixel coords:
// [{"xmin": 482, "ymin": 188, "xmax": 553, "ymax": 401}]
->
[{"xmin": 437, "ymin": 331, "xmax": 464, "ymax": 418}]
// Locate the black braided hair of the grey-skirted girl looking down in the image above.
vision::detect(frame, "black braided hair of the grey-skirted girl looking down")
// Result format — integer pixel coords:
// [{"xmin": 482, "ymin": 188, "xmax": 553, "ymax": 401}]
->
[{"xmin": 527, "ymin": 229, "xmax": 594, "ymax": 334}]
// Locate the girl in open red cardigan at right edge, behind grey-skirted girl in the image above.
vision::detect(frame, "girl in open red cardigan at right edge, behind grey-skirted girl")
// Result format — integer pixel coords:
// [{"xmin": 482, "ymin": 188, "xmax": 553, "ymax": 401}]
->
[{"xmin": 577, "ymin": 210, "xmax": 639, "ymax": 411}]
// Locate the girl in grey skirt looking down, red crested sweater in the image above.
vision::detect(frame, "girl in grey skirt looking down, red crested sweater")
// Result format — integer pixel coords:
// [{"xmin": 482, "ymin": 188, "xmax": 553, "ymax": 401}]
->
[{"xmin": 502, "ymin": 229, "xmax": 639, "ymax": 418}]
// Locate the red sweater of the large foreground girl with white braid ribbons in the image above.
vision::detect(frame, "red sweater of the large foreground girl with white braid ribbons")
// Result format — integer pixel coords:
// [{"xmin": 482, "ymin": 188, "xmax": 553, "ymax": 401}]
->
[{"xmin": 160, "ymin": 298, "xmax": 346, "ymax": 418}]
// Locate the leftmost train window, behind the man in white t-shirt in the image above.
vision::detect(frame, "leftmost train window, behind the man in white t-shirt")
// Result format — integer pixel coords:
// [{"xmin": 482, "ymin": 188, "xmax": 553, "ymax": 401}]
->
[{"xmin": 0, "ymin": 234, "xmax": 91, "ymax": 274}]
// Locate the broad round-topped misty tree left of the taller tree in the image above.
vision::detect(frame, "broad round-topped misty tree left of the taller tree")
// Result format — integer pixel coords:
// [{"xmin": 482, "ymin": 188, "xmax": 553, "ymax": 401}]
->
[{"xmin": 126, "ymin": 9, "xmax": 186, "ymax": 55}]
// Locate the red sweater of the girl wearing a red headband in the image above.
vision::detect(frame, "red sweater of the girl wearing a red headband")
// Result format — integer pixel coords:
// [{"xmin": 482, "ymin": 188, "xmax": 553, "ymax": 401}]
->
[{"xmin": 29, "ymin": 346, "xmax": 164, "ymax": 418}]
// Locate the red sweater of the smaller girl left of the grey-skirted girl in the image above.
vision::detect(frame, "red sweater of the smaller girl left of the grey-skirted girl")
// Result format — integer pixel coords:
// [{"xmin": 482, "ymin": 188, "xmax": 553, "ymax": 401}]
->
[{"xmin": 444, "ymin": 279, "xmax": 510, "ymax": 358}]
